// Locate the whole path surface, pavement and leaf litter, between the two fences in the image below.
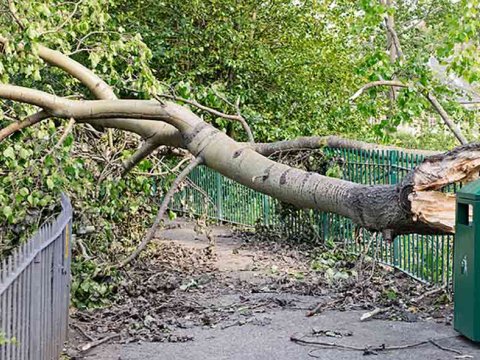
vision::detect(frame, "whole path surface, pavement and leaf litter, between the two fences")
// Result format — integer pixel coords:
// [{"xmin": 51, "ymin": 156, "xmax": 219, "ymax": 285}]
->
[{"xmin": 68, "ymin": 219, "xmax": 480, "ymax": 360}]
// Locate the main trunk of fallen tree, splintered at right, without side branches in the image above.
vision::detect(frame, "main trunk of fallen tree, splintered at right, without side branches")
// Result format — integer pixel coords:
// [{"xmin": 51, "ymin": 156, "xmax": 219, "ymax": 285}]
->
[{"xmin": 0, "ymin": 85, "xmax": 480, "ymax": 235}]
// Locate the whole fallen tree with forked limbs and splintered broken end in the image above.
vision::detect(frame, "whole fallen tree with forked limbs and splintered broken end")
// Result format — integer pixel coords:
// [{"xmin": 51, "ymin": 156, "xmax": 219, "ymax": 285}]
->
[{"xmin": 0, "ymin": 38, "xmax": 480, "ymax": 262}]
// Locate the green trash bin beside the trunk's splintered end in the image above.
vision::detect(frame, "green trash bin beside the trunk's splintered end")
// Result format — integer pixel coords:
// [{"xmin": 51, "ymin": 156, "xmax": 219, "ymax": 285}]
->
[{"xmin": 453, "ymin": 180, "xmax": 480, "ymax": 341}]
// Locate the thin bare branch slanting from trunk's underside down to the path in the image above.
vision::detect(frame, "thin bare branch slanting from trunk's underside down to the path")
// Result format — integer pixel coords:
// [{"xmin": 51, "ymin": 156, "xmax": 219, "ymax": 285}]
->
[{"xmin": 118, "ymin": 157, "xmax": 203, "ymax": 268}]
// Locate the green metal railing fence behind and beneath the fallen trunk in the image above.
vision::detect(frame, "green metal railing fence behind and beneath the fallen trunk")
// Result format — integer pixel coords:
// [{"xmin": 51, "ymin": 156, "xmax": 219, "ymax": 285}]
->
[{"xmin": 167, "ymin": 148, "xmax": 455, "ymax": 286}]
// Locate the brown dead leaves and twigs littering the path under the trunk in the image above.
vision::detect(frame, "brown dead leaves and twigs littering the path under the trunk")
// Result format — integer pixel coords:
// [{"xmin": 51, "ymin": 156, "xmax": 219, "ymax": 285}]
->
[{"xmin": 66, "ymin": 219, "xmax": 459, "ymax": 355}]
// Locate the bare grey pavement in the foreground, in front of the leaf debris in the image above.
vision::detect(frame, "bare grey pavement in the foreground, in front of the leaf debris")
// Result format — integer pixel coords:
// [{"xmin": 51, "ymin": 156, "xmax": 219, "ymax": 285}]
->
[{"xmin": 92, "ymin": 310, "xmax": 480, "ymax": 360}]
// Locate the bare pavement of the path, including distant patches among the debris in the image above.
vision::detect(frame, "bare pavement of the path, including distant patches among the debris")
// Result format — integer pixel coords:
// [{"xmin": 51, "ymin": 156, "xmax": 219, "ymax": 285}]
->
[{"xmin": 82, "ymin": 224, "xmax": 480, "ymax": 360}]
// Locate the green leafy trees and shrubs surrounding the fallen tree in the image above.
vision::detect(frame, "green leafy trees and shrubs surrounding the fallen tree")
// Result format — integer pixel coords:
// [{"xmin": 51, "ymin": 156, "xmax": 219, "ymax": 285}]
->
[{"xmin": 0, "ymin": 0, "xmax": 479, "ymax": 307}]
